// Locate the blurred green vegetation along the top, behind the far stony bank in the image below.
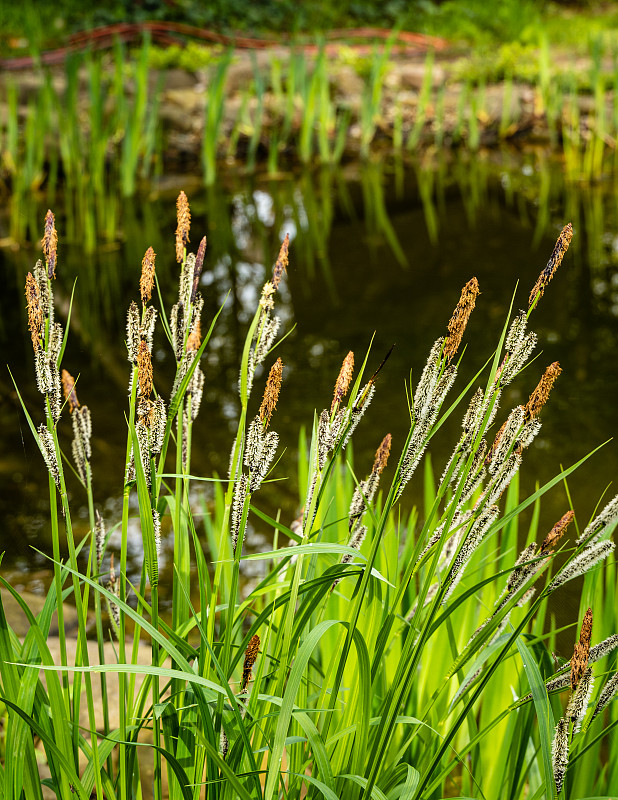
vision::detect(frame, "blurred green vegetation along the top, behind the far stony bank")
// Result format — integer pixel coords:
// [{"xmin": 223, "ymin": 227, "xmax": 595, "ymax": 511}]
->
[{"xmin": 0, "ymin": 0, "xmax": 618, "ymax": 54}]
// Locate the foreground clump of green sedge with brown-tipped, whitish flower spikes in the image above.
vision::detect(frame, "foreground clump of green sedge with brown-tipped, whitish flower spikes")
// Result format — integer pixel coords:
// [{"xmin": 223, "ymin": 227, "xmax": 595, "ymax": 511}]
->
[{"xmin": 0, "ymin": 193, "xmax": 618, "ymax": 800}]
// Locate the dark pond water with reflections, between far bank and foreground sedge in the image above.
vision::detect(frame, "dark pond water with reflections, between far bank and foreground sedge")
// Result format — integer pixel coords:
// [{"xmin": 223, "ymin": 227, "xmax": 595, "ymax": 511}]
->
[{"xmin": 0, "ymin": 153, "xmax": 618, "ymax": 620}]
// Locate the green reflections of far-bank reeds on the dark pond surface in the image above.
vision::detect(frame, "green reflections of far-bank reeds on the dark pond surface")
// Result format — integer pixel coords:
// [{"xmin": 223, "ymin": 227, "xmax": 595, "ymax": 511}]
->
[{"xmin": 8, "ymin": 154, "xmax": 616, "ymax": 362}]
